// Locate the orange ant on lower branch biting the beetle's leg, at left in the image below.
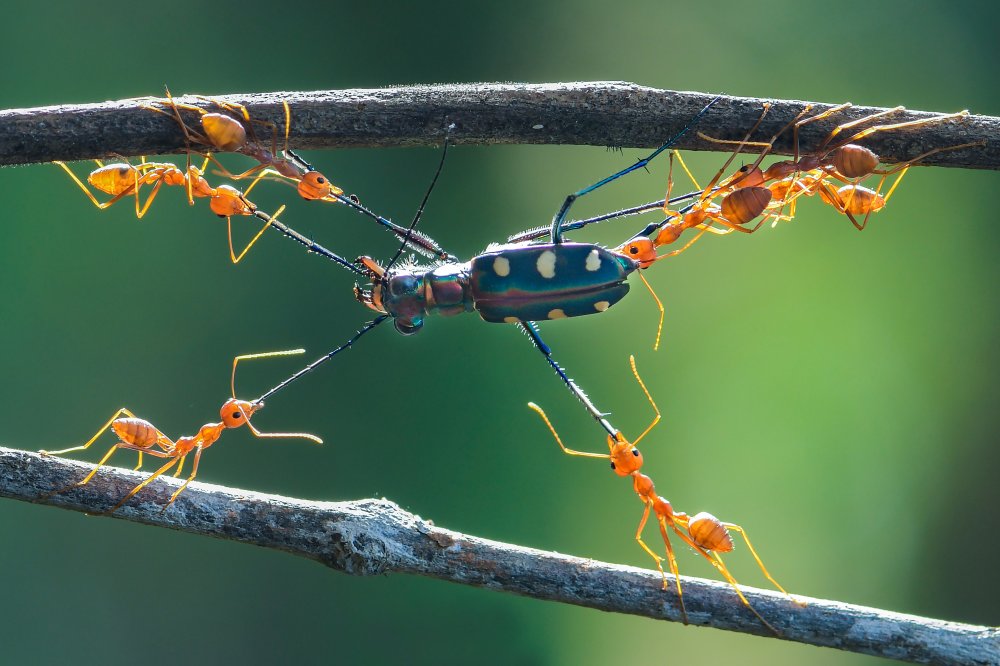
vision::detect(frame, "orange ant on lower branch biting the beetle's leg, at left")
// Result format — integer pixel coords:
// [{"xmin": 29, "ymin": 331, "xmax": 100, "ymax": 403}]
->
[{"xmin": 40, "ymin": 349, "xmax": 323, "ymax": 514}]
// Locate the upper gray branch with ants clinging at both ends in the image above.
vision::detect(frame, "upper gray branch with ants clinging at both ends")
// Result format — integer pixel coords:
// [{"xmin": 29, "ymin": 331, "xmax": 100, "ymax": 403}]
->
[{"xmin": 0, "ymin": 82, "xmax": 1000, "ymax": 169}]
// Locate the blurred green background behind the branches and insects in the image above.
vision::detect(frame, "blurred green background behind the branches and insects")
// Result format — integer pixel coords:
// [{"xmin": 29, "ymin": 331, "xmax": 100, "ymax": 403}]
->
[{"xmin": 0, "ymin": 0, "xmax": 1000, "ymax": 664}]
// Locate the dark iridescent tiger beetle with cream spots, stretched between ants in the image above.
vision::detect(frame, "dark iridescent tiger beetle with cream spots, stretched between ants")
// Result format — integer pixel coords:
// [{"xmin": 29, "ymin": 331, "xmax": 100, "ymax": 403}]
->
[{"xmin": 247, "ymin": 96, "xmax": 721, "ymax": 420}]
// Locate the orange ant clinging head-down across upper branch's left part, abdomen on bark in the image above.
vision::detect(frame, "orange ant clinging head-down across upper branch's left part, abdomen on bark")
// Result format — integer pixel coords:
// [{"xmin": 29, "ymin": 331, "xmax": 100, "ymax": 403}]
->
[{"xmin": 146, "ymin": 88, "xmax": 344, "ymax": 201}]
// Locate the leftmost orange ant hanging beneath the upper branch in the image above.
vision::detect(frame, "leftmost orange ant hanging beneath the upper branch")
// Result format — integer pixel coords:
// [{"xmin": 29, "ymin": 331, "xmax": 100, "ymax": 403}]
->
[{"xmin": 54, "ymin": 157, "xmax": 285, "ymax": 264}]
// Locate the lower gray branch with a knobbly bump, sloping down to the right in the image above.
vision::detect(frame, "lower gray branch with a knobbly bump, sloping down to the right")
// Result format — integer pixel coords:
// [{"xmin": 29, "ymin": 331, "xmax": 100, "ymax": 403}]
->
[{"xmin": 0, "ymin": 448, "xmax": 1000, "ymax": 666}]
